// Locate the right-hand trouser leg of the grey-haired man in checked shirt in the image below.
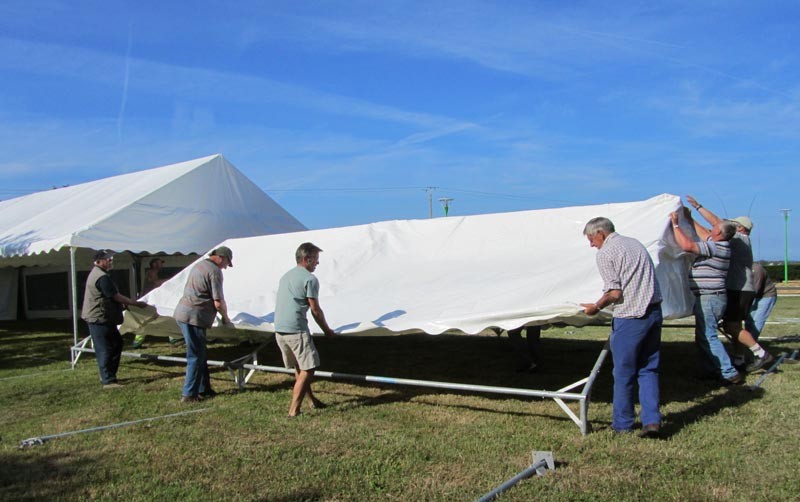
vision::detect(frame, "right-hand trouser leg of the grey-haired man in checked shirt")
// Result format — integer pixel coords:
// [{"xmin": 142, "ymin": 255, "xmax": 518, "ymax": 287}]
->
[{"xmin": 638, "ymin": 307, "xmax": 663, "ymax": 426}]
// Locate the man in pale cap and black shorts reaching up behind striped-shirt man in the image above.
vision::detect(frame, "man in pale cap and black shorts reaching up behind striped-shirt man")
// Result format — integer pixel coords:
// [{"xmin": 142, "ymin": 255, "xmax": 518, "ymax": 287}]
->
[{"xmin": 686, "ymin": 195, "xmax": 775, "ymax": 372}]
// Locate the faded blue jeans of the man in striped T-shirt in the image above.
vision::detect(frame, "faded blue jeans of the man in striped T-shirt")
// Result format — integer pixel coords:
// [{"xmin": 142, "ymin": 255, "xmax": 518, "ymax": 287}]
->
[{"xmin": 694, "ymin": 294, "xmax": 738, "ymax": 378}]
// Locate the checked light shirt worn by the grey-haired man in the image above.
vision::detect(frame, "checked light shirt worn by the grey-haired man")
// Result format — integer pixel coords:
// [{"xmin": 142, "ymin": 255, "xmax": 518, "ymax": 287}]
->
[{"xmin": 597, "ymin": 232, "xmax": 661, "ymax": 319}]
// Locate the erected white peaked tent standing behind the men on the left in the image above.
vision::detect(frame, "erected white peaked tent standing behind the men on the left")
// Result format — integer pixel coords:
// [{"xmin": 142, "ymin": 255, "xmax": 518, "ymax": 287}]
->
[{"xmin": 0, "ymin": 155, "xmax": 305, "ymax": 331}]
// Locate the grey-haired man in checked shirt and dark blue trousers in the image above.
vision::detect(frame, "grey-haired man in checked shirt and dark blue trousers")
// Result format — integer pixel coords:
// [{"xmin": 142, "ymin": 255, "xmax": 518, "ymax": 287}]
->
[{"xmin": 581, "ymin": 217, "xmax": 663, "ymax": 438}]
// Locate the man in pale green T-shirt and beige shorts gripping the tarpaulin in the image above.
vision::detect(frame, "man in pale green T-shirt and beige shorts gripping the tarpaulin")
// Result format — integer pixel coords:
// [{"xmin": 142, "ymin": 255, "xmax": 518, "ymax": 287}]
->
[{"xmin": 275, "ymin": 242, "xmax": 334, "ymax": 417}]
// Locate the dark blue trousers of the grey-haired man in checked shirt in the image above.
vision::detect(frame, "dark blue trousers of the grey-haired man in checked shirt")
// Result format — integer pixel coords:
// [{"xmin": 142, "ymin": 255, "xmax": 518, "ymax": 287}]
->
[{"xmin": 611, "ymin": 305, "xmax": 663, "ymax": 431}]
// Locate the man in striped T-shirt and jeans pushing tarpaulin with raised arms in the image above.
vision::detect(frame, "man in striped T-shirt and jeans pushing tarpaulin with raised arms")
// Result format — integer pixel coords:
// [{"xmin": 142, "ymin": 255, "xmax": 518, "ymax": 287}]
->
[{"xmin": 670, "ymin": 208, "xmax": 744, "ymax": 384}]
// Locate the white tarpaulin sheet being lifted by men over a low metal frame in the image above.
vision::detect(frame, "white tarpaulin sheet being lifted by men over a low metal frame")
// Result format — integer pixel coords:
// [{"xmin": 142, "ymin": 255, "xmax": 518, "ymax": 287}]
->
[{"xmin": 126, "ymin": 194, "xmax": 692, "ymax": 334}]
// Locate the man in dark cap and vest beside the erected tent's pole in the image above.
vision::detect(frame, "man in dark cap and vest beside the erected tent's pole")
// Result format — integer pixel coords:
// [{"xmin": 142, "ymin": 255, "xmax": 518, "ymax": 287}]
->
[{"xmin": 81, "ymin": 249, "xmax": 147, "ymax": 389}]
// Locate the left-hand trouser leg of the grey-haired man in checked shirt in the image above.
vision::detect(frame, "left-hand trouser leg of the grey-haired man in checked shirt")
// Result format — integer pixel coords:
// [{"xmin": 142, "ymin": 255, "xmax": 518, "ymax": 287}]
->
[{"xmin": 611, "ymin": 319, "xmax": 641, "ymax": 432}]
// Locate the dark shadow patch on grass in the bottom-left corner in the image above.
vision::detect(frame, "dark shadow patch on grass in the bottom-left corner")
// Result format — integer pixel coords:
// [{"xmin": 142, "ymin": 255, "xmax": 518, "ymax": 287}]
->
[{"xmin": 0, "ymin": 451, "xmax": 96, "ymax": 500}]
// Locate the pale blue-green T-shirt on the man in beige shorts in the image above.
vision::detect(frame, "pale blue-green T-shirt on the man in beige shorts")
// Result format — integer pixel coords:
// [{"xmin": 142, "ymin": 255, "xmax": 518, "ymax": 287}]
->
[{"xmin": 275, "ymin": 267, "xmax": 319, "ymax": 333}]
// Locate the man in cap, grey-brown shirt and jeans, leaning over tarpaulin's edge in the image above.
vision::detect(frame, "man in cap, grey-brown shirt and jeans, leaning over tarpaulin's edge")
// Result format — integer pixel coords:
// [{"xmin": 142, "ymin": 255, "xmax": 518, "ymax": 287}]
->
[{"xmin": 173, "ymin": 246, "xmax": 233, "ymax": 403}]
